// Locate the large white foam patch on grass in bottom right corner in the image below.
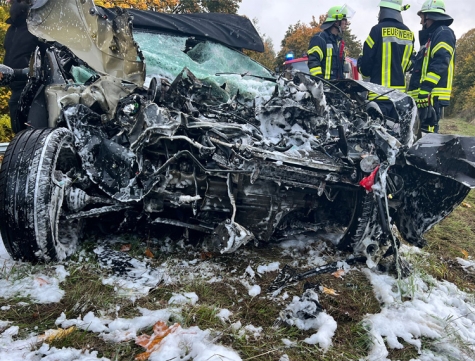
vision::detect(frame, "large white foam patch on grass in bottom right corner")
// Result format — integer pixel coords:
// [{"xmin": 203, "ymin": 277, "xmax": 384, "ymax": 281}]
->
[{"xmin": 363, "ymin": 269, "xmax": 475, "ymax": 361}]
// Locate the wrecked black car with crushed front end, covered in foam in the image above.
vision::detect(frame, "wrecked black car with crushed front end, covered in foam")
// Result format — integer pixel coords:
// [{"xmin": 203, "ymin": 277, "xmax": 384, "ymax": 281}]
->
[{"xmin": 0, "ymin": 0, "xmax": 475, "ymax": 267}]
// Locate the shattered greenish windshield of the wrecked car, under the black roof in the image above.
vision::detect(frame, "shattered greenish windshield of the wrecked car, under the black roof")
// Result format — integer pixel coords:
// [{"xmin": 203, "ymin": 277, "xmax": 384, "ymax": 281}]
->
[{"xmin": 134, "ymin": 31, "xmax": 275, "ymax": 100}]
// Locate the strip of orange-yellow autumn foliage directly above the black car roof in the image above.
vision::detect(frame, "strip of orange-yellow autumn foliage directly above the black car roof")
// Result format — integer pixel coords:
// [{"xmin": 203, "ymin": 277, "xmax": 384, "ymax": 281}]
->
[{"xmin": 95, "ymin": 0, "xmax": 242, "ymax": 14}]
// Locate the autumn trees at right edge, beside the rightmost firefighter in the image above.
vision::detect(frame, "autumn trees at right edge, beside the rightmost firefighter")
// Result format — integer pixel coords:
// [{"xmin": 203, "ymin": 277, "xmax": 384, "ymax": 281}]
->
[{"xmin": 449, "ymin": 28, "xmax": 475, "ymax": 120}]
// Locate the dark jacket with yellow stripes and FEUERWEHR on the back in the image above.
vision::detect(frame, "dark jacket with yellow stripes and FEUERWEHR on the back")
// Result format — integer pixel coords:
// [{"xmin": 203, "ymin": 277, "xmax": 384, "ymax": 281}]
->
[{"xmin": 358, "ymin": 18, "xmax": 414, "ymax": 100}]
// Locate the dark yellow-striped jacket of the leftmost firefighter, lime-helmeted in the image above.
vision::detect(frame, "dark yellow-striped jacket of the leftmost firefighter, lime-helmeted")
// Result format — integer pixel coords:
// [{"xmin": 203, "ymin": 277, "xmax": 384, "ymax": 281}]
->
[{"xmin": 307, "ymin": 29, "xmax": 345, "ymax": 80}]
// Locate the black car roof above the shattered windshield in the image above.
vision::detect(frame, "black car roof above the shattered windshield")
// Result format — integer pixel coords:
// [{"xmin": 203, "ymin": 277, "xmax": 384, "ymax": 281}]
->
[{"xmin": 98, "ymin": 7, "xmax": 264, "ymax": 52}]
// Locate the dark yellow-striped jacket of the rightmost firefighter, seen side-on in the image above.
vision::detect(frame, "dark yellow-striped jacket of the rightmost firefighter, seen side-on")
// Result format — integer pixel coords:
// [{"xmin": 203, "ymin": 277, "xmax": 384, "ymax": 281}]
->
[{"xmin": 408, "ymin": 23, "xmax": 456, "ymax": 106}]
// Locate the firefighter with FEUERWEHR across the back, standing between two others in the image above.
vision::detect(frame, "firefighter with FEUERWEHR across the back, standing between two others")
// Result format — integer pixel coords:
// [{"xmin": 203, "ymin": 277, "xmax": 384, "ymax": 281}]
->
[{"xmin": 357, "ymin": 0, "xmax": 414, "ymax": 119}]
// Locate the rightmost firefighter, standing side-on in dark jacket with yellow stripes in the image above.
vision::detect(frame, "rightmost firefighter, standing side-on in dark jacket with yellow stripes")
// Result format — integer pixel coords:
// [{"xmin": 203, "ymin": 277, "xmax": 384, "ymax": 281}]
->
[{"xmin": 409, "ymin": 0, "xmax": 456, "ymax": 133}]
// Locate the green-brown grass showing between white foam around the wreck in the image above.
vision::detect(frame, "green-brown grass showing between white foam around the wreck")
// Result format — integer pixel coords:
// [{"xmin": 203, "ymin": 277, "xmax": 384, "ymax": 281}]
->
[{"xmin": 0, "ymin": 119, "xmax": 475, "ymax": 361}]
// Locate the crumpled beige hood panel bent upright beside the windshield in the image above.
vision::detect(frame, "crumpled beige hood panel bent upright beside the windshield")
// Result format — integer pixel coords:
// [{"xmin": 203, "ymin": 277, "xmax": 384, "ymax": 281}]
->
[{"xmin": 27, "ymin": 0, "xmax": 145, "ymax": 86}]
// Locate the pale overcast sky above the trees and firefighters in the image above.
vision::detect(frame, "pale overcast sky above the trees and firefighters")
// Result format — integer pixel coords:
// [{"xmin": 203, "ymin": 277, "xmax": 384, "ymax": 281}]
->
[{"xmin": 238, "ymin": 0, "xmax": 475, "ymax": 51}]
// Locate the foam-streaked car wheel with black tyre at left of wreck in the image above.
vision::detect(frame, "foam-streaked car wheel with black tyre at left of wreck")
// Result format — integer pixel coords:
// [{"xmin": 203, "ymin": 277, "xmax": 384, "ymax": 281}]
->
[{"xmin": 0, "ymin": 128, "xmax": 81, "ymax": 262}]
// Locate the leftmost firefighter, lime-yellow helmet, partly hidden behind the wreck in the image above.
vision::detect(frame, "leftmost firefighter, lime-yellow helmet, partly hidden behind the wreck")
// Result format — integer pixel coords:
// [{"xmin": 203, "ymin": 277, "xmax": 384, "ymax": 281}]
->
[{"xmin": 307, "ymin": 5, "xmax": 354, "ymax": 80}]
